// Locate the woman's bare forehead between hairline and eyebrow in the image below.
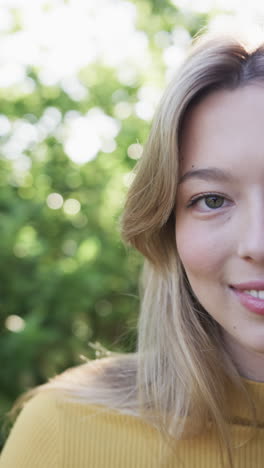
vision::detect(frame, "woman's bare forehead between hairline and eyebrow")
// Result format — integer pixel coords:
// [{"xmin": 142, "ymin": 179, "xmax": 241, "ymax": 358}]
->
[{"xmin": 180, "ymin": 83, "xmax": 264, "ymax": 171}]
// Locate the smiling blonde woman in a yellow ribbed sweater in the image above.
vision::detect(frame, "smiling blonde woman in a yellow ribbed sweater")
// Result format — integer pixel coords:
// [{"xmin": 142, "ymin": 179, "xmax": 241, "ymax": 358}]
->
[{"xmin": 0, "ymin": 29, "xmax": 264, "ymax": 468}]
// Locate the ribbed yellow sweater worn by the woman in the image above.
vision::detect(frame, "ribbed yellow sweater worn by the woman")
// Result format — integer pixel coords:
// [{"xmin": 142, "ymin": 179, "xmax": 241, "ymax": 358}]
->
[{"xmin": 0, "ymin": 380, "xmax": 264, "ymax": 468}]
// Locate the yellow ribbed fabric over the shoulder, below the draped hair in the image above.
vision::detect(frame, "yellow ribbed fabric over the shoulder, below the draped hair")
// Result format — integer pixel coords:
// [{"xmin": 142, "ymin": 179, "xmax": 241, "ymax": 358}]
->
[{"xmin": 0, "ymin": 389, "xmax": 161, "ymax": 468}]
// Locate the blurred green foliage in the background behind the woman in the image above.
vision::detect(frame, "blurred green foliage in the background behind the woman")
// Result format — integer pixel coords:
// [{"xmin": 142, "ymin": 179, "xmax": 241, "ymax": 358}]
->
[{"xmin": 0, "ymin": 0, "xmax": 214, "ymax": 448}]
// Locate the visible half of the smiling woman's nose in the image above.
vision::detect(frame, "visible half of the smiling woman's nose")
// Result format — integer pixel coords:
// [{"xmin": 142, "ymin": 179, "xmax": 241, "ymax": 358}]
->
[{"xmin": 238, "ymin": 200, "xmax": 264, "ymax": 265}]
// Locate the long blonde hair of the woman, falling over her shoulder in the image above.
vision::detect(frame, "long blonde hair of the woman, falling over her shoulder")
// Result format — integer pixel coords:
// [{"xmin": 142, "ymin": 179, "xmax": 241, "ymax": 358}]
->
[{"xmin": 8, "ymin": 28, "xmax": 264, "ymax": 466}]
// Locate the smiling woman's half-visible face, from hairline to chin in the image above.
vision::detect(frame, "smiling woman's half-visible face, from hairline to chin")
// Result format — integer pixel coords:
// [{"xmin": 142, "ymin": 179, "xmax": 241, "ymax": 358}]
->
[{"xmin": 176, "ymin": 84, "xmax": 264, "ymax": 380}]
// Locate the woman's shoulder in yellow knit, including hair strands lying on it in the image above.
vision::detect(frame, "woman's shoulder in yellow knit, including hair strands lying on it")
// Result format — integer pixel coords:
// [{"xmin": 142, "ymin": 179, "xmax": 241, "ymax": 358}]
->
[{"xmin": 0, "ymin": 356, "xmax": 166, "ymax": 468}]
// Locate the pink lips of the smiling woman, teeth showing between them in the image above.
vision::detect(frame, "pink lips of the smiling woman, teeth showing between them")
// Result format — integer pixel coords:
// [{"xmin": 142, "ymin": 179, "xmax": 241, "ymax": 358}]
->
[{"xmin": 230, "ymin": 281, "xmax": 264, "ymax": 315}]
